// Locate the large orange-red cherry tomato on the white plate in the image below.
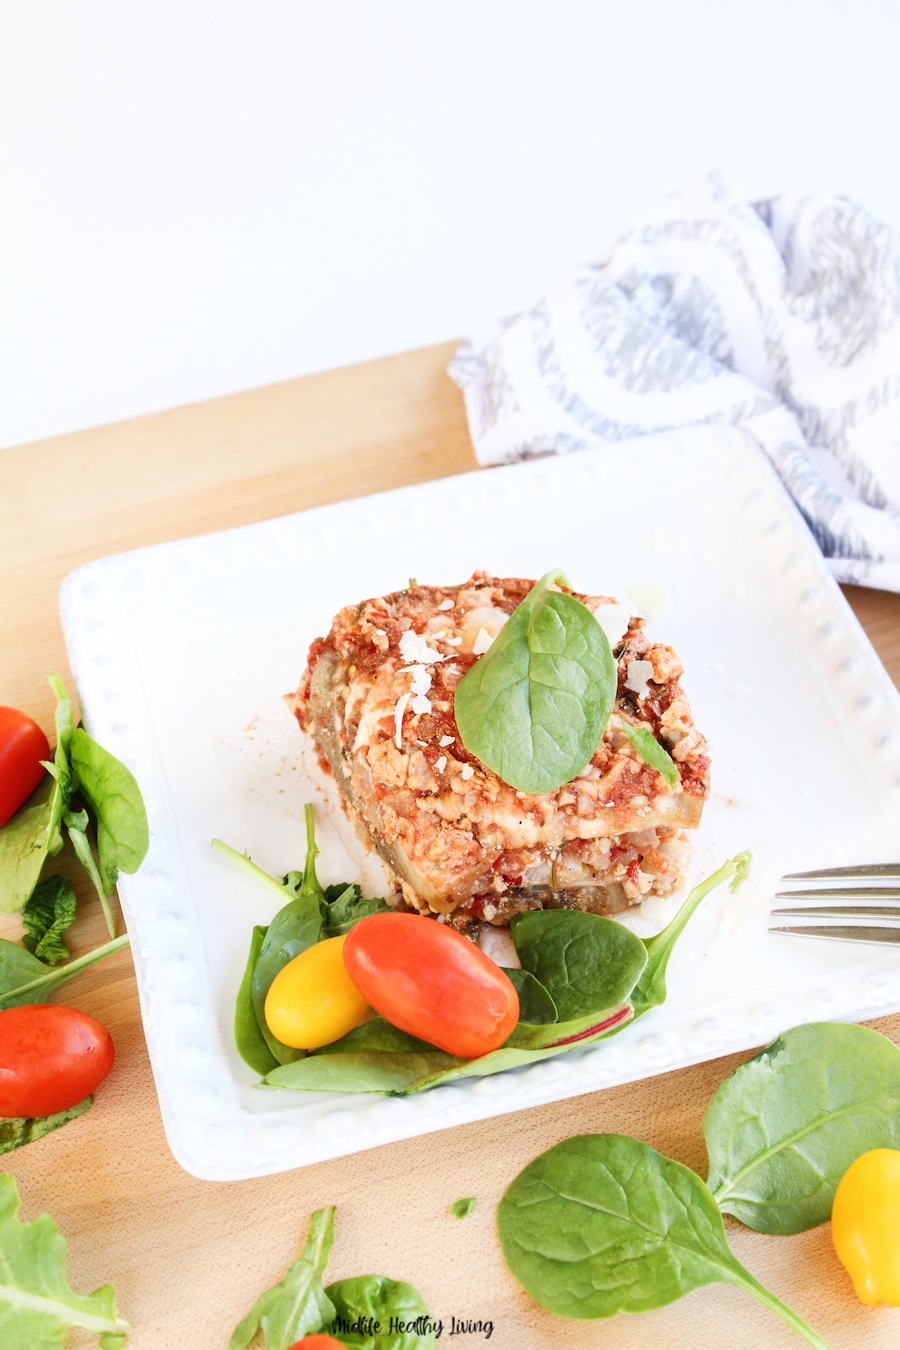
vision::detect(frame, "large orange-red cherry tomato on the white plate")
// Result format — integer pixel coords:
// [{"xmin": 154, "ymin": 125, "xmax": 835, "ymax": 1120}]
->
[{"xmin": 344, "ymin": 914, "xmax": 518, "ymax": 1060}]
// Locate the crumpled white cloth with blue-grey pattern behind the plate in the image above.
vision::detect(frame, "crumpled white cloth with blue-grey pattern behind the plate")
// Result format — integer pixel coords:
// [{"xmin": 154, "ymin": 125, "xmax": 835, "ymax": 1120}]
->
[{"xmin": 449, "ymin": 176, "xmax": 900, "ymax": 591}]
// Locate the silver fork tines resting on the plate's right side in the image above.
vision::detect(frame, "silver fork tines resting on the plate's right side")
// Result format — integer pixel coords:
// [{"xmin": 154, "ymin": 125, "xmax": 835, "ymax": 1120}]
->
[{"xmin": 769, "ymin": 863, "xmax": 900, "ymax": 944}]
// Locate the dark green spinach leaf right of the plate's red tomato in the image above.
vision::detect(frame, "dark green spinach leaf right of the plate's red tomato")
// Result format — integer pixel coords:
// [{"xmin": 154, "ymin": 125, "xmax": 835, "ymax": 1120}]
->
[{"xmin": 510, "ymin": 910, "xmax": 648, "ymax": 1022}]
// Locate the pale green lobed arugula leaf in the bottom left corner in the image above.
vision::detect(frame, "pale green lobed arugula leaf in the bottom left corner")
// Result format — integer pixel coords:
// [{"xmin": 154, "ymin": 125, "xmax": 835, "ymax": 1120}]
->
[{"xmin": 0, "ymin": 1172, "xmax": 131, "ymax": 1350}]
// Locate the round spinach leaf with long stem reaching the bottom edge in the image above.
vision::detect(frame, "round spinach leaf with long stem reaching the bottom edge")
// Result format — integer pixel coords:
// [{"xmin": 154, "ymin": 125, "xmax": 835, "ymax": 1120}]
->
[{"xmin": 497, "ymin": 1134, "xmax": 827, "ymax": 1350}]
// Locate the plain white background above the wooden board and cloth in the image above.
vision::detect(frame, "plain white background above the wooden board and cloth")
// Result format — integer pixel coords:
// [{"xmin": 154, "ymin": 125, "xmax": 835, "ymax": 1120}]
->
[{"xmin": 0, "ymin": 0, "xmax": 900, "ymax": 446}]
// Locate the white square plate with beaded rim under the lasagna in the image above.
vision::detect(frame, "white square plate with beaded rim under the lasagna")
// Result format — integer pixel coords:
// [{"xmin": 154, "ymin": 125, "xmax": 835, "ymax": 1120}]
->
[{"xmin": 61, "ymin": 429, "xmax": 900, "ymax": 1181}]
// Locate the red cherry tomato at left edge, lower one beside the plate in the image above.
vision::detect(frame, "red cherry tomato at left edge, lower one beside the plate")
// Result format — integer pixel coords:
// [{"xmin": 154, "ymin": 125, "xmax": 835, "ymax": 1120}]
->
[{"xmin": 0, "ymin": 1003, "xmax": 115, "ymax": 1116}]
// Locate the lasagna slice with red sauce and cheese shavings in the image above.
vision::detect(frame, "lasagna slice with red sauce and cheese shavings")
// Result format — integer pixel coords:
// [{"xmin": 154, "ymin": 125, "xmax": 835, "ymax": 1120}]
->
[{"xmin": 287, "ymin": 572, "xmax": 710, "ymax": 932}]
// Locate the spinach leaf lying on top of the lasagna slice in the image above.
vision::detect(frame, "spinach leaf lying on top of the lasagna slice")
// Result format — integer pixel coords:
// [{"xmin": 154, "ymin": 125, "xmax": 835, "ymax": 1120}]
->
[{"xmin": 453, "ymin": 570, "xmax": 617, "ymax": 792}]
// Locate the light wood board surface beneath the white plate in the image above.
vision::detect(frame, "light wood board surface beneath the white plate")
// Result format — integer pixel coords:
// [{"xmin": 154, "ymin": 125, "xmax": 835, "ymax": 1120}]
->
[{"xmin": 0, "ymin": 343, "xmax": 900, "ymax": 1350}]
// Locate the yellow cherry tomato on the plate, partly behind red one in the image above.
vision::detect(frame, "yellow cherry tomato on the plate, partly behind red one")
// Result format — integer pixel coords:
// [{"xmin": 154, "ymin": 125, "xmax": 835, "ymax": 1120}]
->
[{"xmin": 266, "ymin": 936, "xmax": 368, "ymax": 1050}]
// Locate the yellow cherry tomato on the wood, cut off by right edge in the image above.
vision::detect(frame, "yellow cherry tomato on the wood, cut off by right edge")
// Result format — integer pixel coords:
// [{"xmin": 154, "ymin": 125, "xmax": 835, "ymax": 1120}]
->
[{"xmin": 831, "ymin": 1149, "xmax": 900, "ymax": 1308}]
